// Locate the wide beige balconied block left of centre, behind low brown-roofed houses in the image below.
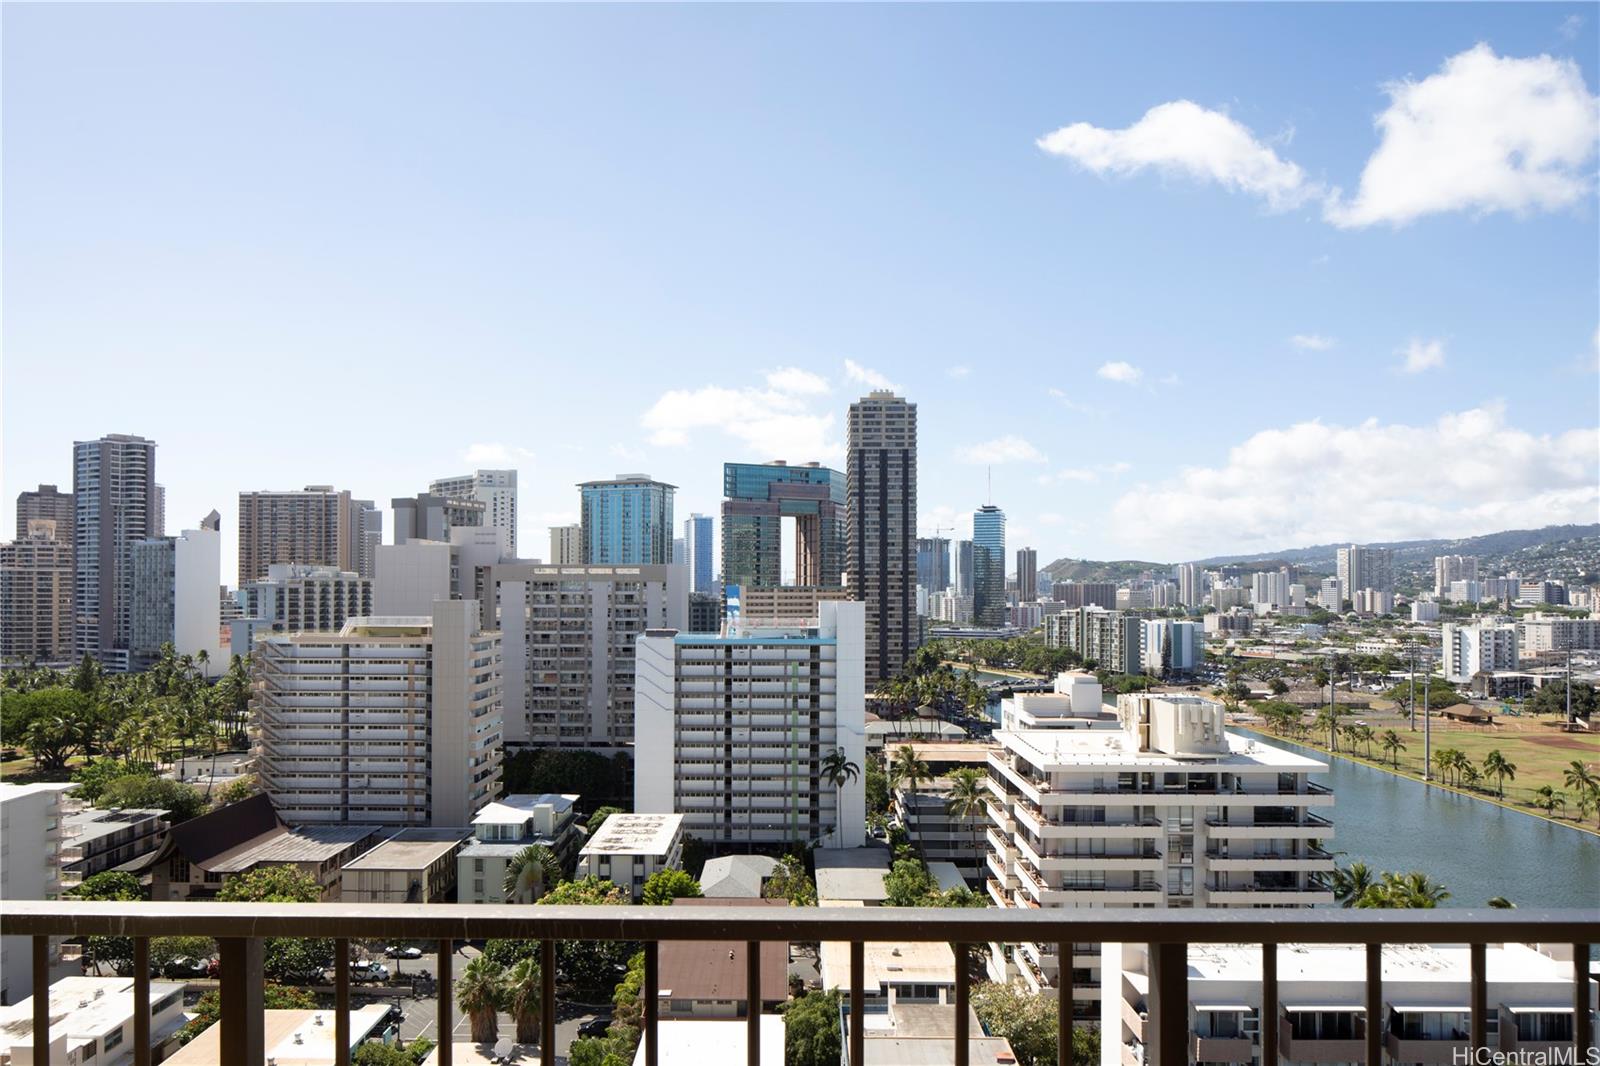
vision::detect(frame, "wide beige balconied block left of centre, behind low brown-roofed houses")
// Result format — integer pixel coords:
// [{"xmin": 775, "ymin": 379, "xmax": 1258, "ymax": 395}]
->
[{"xmin": 251, "ymin": 600, "xmax": 502, "ymax": 826}]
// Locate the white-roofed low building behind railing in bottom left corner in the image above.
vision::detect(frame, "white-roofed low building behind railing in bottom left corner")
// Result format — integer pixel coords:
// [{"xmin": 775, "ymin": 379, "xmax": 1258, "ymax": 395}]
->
[{"xmin": 0, "ymin": 976, "xmax": 184, "ymax": 1066}]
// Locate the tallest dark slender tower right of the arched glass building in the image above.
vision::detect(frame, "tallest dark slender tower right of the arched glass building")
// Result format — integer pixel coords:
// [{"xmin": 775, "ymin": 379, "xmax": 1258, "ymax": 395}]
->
[{"xmin": 845, "ymin": 391, "xmax": 921, "ymax": 685}]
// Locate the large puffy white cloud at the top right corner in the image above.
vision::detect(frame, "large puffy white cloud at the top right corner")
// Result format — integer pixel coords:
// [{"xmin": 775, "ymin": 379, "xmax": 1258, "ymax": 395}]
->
[{"xmin": 1323, "ymin": 43, "xmax": 1600, "ymax": 227}]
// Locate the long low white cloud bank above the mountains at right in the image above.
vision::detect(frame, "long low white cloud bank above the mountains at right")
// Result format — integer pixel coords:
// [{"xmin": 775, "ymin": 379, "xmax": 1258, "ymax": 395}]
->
[{"xmin": 1110, "ymin": 405, "xmax": 1600, "ymax": 560}]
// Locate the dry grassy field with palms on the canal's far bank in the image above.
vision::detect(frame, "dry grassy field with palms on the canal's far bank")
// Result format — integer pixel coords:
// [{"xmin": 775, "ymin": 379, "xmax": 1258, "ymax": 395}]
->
[{"xmin": 1235, "ymin": 701, "xmax": 1600, "ymax": 832}]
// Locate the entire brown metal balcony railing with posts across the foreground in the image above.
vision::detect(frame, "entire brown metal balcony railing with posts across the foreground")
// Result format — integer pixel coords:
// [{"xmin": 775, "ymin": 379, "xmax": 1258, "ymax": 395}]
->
[{"xmin": 0, "ymin": 900, "xmax": 1600, "ymax": 1066}]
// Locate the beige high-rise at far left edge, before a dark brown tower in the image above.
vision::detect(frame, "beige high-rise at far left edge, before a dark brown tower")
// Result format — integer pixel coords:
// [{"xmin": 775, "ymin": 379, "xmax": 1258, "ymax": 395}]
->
[{"xmin": 0, "ymin": 518, "xmax": 72, "ymax": 663}]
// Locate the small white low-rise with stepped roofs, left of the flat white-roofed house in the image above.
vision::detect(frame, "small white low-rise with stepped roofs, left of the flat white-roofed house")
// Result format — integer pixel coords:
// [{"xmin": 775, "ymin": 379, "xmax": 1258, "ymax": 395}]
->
[{"xmin": 456, "ymin": 792, "xmax": 582, "ymax": 903}]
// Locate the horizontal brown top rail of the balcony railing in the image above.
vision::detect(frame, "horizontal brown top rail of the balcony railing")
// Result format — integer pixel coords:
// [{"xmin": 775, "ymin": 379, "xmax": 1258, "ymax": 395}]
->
[{"xmin": 0, "ymin": 900, "xmax": 1600, "ymax": 944}]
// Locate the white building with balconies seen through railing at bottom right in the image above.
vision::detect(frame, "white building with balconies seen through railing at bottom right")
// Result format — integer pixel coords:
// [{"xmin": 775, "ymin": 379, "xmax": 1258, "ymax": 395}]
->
[{"xmin": 1099, "ymin": 944, "xmax": 1594, "ymax": 1066}]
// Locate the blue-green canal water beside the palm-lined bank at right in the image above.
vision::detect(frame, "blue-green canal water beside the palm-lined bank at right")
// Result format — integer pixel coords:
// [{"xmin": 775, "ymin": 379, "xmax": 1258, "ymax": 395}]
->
[{"xmin": 1234, "ymin": 730, "xmax": 1600, "ymax": 908}]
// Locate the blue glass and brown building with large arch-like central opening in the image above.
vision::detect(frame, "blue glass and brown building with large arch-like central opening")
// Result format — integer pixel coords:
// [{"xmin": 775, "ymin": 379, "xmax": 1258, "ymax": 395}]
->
[{"xmin": 722, "ymin": 459, "xmax": 845, "ymax": 589}]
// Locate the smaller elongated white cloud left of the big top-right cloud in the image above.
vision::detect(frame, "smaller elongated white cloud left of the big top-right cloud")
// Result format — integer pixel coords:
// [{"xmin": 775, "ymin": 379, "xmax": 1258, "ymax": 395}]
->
[{"xmin": 1035, "ymin": 99, "xmax": 1322, "ymax": 211}]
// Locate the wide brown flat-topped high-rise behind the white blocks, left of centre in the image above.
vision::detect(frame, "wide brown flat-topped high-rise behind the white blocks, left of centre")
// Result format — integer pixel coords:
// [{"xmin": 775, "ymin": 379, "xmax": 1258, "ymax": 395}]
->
[{"xmin": 238, "ymin": 485, "xmax": 358, "ymax": 584}]
